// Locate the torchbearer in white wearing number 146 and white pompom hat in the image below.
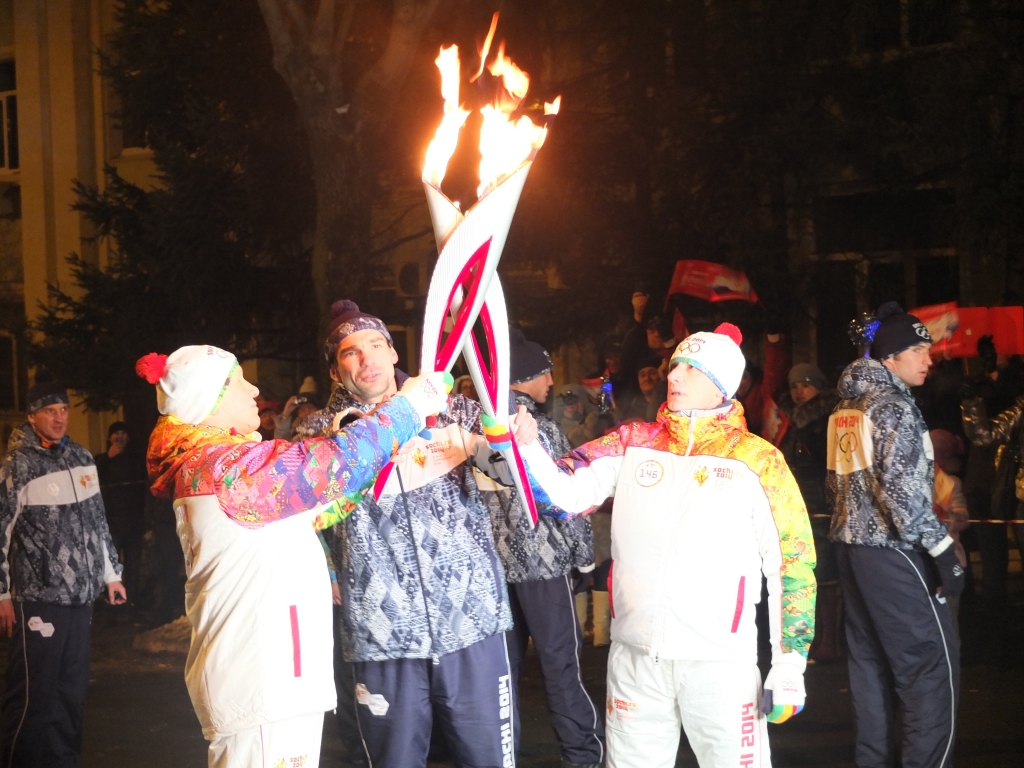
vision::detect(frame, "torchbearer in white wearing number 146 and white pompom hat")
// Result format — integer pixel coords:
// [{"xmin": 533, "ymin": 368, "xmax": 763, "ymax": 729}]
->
[{"xmin": 522, "ymin": 324, "xmax": 815, "ymax": 768}]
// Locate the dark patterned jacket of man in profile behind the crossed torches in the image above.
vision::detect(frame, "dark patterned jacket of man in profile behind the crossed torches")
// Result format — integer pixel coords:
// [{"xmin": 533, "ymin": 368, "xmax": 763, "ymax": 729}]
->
[{"xmin": 481, "ymin": 391, "xmax": 594, "ymax": 584}]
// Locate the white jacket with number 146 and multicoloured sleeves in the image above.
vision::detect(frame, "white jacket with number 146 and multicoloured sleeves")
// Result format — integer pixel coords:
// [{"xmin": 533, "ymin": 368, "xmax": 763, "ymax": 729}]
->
[{"xmin": 522, "ymin": 402, "xmax": 817, "ymax": 662}]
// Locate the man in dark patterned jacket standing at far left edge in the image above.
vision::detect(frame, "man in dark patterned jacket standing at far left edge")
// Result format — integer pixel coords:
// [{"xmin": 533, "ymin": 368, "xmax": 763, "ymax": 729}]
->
[{"xmin": 0, "ymin": 381, "xmax": 126, "ymax": 768}]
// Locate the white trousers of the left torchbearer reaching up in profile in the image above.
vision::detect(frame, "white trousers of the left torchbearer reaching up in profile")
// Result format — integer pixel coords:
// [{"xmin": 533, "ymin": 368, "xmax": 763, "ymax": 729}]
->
[{"xmin": 209, "ymin": 713, "xmax": 324, "ymax": 768}]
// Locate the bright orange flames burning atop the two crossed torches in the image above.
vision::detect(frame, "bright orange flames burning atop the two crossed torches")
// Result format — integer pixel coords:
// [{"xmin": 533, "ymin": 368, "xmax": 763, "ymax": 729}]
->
[{"xmin": 423, "ymin": 13, "xmax": 561, "ymax": 198}]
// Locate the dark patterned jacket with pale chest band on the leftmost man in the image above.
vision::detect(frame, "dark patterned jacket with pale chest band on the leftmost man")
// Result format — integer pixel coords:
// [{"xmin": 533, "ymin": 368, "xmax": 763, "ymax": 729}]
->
[{"xmin": 0, "ymin": 423, "xmax": 121, "ymax": 605}]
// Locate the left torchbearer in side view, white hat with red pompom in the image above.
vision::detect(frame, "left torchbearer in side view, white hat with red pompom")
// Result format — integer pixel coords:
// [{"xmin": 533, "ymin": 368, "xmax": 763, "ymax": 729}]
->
[{"xmin": 136, "ymin": 345, "xmax": 447, "ymax": 768}]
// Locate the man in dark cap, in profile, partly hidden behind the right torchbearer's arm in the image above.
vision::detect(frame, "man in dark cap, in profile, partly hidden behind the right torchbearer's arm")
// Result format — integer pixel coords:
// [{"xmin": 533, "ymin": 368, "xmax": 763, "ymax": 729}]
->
[{"xmin": 489, "ymin": 329, "xmax": 604, "ymax": 768}]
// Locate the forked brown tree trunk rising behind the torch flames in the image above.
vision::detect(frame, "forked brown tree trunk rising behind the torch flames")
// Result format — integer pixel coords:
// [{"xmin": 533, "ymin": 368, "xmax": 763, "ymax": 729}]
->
[{"xmin": 259, "ymin": 0, "xmax": 438, "ymax": 330}]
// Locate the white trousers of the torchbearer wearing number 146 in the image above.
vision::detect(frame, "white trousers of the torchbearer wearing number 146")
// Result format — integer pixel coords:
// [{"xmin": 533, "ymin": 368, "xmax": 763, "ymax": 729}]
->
[{"xmin": 606, "ymin": 642, "xmax": 771, "ymax": 768}]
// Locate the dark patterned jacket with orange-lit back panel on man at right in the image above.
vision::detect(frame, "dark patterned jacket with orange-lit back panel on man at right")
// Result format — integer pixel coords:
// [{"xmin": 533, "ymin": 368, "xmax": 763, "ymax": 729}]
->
[{"xmin": 826, "ymin": 357, "xmax": 946, "ymax": 550}]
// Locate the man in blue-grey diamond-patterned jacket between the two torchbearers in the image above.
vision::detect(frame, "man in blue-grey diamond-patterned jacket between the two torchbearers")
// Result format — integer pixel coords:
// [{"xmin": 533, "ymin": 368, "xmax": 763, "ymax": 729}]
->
[{"xmin": 296, "ymin": 300, "xmax": 532, "ymax": 768}]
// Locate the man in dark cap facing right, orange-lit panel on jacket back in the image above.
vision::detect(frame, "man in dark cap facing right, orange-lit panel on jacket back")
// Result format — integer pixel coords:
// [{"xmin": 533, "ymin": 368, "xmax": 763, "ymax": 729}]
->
[{"xmin": 827, "ymin": 302, "xmax": 964, "ymax": 768}]
